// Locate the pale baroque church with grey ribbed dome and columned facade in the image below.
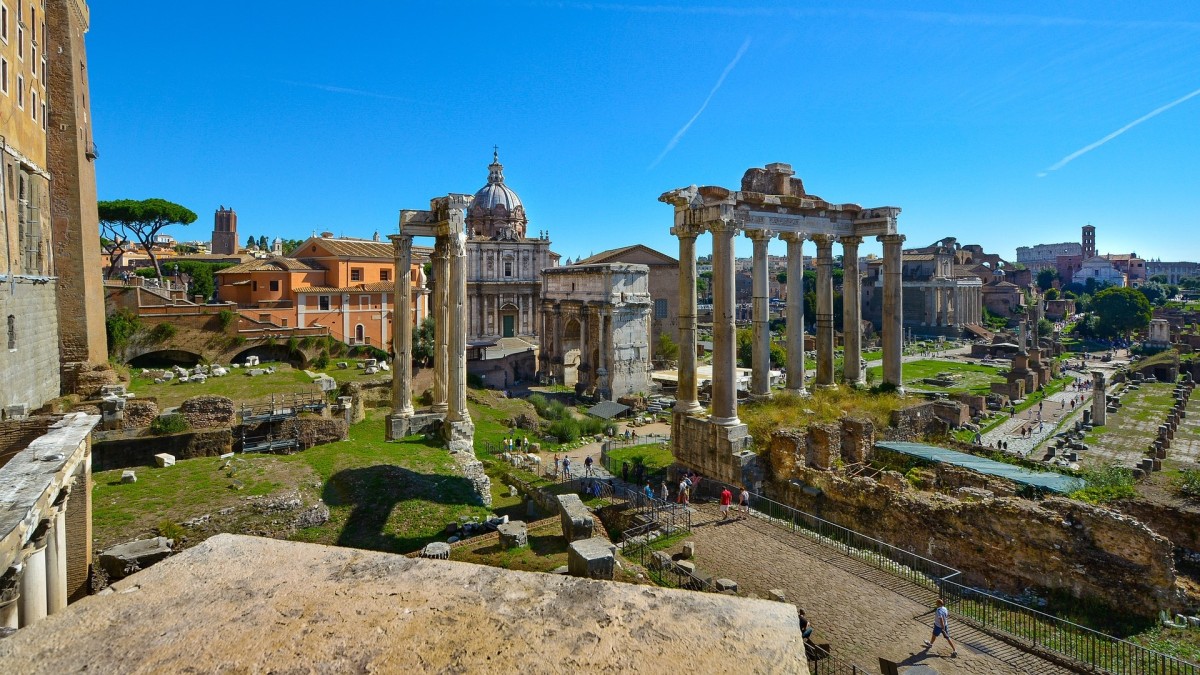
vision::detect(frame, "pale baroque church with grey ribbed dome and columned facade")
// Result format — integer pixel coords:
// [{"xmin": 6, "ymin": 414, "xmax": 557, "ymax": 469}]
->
[{"xmin": 466, "ymin": 155, "xmax": 558, "ymax": 342}]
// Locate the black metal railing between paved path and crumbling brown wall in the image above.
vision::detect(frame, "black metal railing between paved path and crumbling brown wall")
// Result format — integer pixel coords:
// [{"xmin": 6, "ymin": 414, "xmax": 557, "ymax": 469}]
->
[{"xmin": 696, "ymin": 478, "xmax": 1200, "ymax": 675}]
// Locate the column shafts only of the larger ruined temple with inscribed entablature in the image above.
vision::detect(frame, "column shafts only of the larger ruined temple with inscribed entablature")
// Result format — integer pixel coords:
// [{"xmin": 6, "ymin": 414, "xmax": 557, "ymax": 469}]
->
[{"xmin": 672, "ymin": 220, "xmax": 905, "ymax": 425}]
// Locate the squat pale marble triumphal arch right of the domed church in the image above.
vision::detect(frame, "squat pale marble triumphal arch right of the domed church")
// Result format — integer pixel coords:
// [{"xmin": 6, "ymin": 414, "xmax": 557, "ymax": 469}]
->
[{"xmin": 541, "ymin": 263, "xmax": 652, "ymax": 400}]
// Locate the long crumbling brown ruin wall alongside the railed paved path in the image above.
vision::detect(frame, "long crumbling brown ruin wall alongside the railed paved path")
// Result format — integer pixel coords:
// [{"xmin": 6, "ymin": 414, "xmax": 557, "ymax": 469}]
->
[{"xmin": 767, "ymin": 444, "xmax": 1175, "ymax": 617}]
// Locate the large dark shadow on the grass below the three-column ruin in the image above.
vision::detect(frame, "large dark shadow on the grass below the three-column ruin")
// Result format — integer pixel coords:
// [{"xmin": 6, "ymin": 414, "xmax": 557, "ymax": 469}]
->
[{"xmin": 322, "ymin": 465, "xmax": 482, "ymax": 552}]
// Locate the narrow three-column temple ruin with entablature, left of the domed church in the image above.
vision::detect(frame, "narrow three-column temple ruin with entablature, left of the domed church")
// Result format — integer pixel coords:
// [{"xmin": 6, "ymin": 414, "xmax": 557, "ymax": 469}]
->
[{"xmin": 388, "ymin": 193, "xmax": 475, "ymax": 453}]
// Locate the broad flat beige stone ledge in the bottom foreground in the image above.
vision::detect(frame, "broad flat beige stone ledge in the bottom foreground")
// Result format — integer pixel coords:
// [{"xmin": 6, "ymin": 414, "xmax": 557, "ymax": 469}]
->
[{"xmin": 0, "ymin": 534, "xmax": 806, "ymax": 673}]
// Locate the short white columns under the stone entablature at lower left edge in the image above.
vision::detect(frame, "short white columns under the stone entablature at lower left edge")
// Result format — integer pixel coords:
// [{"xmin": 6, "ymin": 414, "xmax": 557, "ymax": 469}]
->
[{"xmin": 0, "ymin": 490, "xmax": 68, "ymax": 628}]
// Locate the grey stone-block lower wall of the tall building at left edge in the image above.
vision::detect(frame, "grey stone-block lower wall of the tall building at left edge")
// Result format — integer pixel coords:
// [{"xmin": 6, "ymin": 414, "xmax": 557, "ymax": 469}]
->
[{"xmin": 0, "ymin": 275, "xmax": 60, "ymax": 411}]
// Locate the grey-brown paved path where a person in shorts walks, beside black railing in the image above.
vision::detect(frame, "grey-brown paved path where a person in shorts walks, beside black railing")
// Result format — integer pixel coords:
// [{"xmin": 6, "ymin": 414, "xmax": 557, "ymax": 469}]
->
[{"xmin": 672, "ymin": 503, "xmax": 1069, "ymax": 675}]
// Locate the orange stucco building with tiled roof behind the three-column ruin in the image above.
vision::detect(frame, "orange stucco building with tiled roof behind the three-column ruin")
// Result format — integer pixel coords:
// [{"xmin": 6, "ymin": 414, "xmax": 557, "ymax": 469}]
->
[{"xmin": 216, "ymin": 233, "xmax": 431, "ymax": 351}]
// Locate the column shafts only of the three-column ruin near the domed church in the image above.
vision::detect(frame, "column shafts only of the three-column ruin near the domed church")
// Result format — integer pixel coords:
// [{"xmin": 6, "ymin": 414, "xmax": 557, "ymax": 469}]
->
[{"xmin": 388, "ymin": 232, "xmax": 470, "ymax": 422}]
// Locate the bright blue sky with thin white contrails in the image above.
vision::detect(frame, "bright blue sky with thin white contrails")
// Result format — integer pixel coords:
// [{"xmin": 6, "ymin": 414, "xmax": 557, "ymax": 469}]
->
[{"xmin": 88, "ymin": 0, "xmax": 1200, "ymax": 261}]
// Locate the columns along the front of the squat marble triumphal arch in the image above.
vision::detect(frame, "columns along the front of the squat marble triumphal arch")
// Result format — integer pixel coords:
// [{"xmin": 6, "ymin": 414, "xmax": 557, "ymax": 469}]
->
[{"xmin": 541, "ymin": 299, "xmax": 612, "ymax": 399}]
